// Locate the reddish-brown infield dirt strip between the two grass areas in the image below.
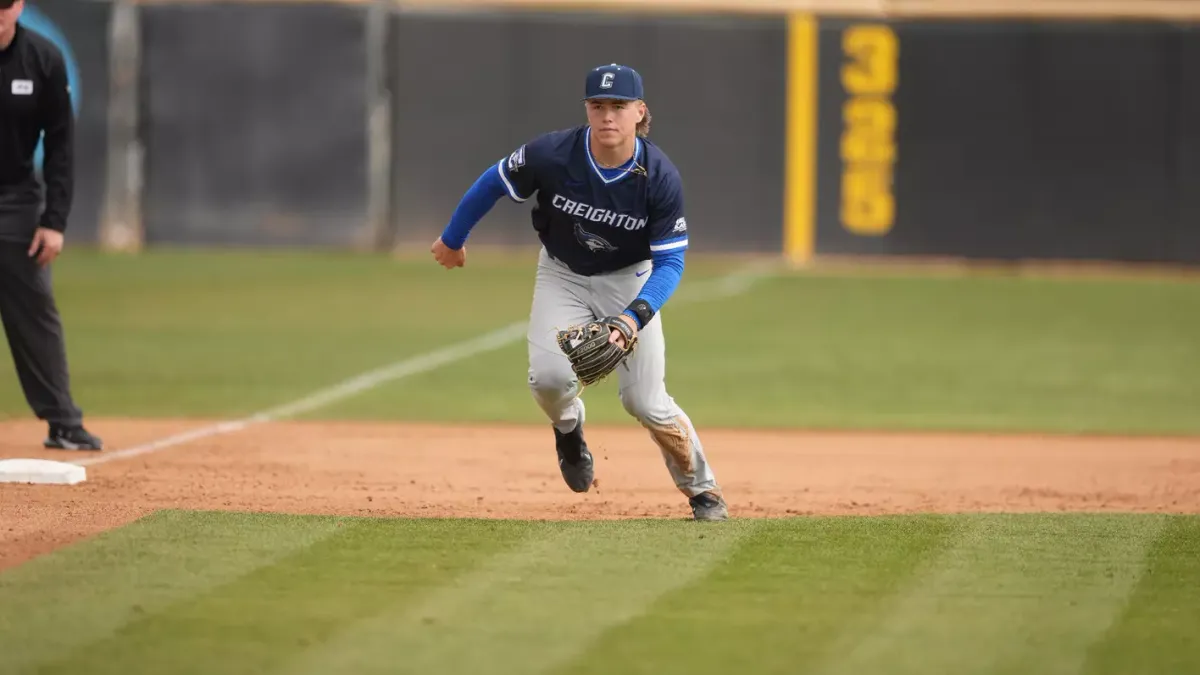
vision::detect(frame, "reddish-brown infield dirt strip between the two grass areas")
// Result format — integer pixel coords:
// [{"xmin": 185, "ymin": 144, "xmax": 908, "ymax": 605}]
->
[{"xmin": 0, "ymin": 419, "xmax": 1200, "ymax": 569}]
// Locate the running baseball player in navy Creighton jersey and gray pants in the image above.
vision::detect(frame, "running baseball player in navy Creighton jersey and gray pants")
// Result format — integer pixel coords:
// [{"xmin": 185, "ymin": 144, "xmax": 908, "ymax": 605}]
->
[{"xmin": 431, "ymin": 64, "xmax": 728, "ymax": 520}]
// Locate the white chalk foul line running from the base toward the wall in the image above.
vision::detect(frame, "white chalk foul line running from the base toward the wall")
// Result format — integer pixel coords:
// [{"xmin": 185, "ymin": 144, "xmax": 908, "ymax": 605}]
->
[{"xmin": 71, "ymin": 265, "xmax": 769, "ymax": 466}]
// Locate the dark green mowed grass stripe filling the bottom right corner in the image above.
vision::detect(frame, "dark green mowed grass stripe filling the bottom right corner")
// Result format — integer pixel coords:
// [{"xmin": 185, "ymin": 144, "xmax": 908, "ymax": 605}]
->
[{"xmin": 1082, "ymin": 516, "xmax": 1200, "ymax": 675}]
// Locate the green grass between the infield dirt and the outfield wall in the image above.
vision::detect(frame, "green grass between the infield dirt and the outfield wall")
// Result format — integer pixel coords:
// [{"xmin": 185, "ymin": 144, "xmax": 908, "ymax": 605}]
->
[{"xmin": 0, "ymin": 250, "xmax": 1200, "ymax": 434}]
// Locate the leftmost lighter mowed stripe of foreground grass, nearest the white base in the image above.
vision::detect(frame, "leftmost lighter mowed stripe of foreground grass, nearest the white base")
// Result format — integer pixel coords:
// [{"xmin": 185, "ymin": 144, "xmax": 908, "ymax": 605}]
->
[{"xmin": 0, "ymin": 510, "xmax": 341, "ymax": 674}]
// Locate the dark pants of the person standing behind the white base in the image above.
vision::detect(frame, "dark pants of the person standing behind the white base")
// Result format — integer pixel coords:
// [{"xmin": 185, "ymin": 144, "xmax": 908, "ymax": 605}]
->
[{"xmin": 0, "ymin": 240, "xmax": 83, "ymax": 425}]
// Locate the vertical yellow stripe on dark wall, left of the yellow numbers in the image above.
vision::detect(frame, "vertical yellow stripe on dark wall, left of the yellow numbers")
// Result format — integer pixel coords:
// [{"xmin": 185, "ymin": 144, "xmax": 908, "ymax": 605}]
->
[{"xmin": 784, "ymin": 14, "xmax": 818, "ymax": 263}]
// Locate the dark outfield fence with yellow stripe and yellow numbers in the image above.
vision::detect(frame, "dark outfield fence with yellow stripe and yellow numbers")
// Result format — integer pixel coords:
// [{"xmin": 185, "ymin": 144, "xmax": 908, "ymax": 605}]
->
[{"xmin": 26, "ymin": 0, "xmax": 1200, "ymax": 263}]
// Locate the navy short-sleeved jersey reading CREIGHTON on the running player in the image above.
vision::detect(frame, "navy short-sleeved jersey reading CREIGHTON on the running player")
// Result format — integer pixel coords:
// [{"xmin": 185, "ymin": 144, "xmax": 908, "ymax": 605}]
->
[{"xmin": 497, "ymin": 126, "xmax": 688, "ymax": 275}]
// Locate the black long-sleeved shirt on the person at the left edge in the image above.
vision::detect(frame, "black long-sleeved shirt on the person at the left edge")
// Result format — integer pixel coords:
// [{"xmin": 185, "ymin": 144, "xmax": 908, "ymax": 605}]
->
[{"xmin": 0, "ymin": 23, "xmax": 74, "ymax": 244}]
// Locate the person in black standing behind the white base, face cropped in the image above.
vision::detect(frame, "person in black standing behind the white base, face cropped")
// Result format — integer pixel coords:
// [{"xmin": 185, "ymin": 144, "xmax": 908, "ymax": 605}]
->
[{"xmin": 0, "ymin": 0, "xmax": 103, "ymax": 450}]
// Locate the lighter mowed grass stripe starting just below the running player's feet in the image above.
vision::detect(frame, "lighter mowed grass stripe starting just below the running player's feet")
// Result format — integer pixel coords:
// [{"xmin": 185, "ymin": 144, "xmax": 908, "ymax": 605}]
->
[{"xmin": 277, "ymin": 521, "xmax": 757, "ymax": 675}]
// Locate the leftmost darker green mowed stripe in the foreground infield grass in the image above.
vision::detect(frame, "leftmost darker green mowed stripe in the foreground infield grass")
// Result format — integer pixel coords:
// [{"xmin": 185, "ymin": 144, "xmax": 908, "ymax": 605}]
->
[{"xmin": 31, "ymin": 519, "xmax": 529, "ymax": 675}]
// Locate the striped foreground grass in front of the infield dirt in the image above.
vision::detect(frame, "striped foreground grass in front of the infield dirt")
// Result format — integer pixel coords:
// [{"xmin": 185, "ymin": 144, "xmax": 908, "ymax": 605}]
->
[{"xmin": 0, "ymin": 512, "xmax": 1200, "ymax": 675}]
